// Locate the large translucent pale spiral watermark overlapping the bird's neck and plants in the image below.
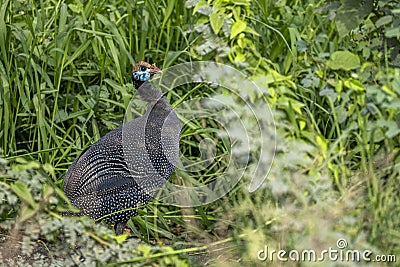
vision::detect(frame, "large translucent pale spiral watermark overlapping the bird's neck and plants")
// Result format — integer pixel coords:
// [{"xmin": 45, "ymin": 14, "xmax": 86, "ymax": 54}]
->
[{"xmin": 122, "ymin": 61, "xmax": 276, "ymax": 207}]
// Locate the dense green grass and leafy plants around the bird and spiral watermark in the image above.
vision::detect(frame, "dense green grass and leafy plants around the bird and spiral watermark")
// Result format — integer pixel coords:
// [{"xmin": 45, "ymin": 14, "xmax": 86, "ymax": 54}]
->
[{"xmin": 0, "ymin": 0, "xmax": 400, "ymax": 266}]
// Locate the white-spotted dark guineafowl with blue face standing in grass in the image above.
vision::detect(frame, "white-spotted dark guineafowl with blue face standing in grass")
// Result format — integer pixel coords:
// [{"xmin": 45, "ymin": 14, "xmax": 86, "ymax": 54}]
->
[{"xmin": 64, "ymin": 61, "xmax": 180, "ymax": 235}]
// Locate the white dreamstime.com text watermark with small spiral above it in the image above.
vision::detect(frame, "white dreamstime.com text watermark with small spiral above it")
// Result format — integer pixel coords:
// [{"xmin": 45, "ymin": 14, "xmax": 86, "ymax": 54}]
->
[{"xmin": 257, "ymin": 241, "xmax": 396, "ymax": 262}]
